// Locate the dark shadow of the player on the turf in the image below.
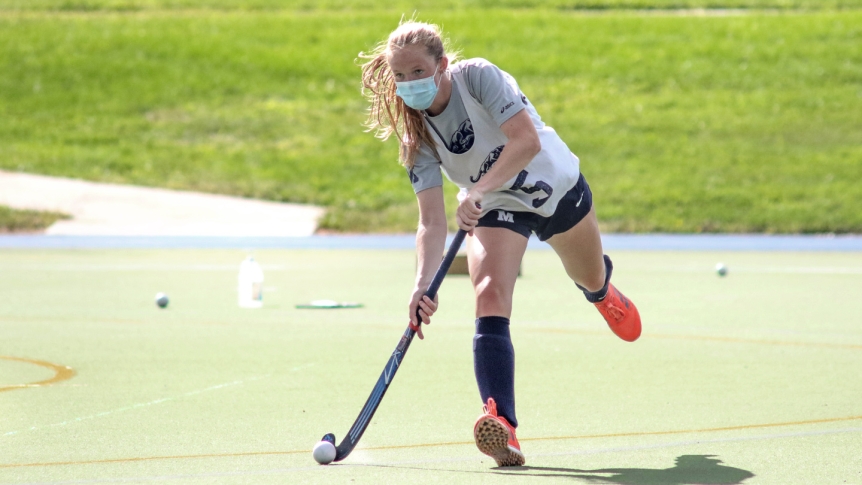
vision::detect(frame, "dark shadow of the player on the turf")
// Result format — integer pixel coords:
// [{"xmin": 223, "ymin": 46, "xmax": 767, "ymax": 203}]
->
[{"xmin": 493, "ymin": 455, "xmax": 754, "ymax": 485}]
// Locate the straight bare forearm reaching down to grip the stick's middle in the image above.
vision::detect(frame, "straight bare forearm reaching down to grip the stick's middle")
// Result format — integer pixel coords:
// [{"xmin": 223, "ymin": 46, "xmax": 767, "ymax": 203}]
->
[{"xmin": 408, "ymin": 187, "xmax": 447, "ymax": 339}]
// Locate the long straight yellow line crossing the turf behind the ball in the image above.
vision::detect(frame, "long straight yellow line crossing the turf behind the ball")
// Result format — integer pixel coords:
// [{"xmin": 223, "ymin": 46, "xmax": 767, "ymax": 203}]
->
[{"xmin": 0, "ymin": 416, "xmax": 862, "ymax": 469}]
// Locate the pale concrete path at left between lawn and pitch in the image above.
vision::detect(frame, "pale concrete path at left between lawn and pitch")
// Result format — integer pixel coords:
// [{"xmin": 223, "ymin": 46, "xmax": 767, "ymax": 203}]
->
[{"xmin": 0, "ymin": 171, "xmax": 324, "ymax": 237}]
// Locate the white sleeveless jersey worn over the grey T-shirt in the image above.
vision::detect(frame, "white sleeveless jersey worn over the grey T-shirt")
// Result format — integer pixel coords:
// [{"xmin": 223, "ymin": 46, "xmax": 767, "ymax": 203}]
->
[{"xmin": 425, "ymin": 66, "xmax": 580, "ymax": 217}]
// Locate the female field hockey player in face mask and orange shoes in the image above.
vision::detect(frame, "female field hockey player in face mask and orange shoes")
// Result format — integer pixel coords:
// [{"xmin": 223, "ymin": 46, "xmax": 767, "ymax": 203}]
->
[{"xmin": 360, "ymin": 21, "xmax": 641, "ymax": 466}]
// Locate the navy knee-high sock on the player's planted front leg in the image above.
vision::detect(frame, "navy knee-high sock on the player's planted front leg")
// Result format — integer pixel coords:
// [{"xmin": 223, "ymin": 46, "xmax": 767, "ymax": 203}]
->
[{"xmin": 473, "ymin": 317, "xmax": 518, "ymax": 427}]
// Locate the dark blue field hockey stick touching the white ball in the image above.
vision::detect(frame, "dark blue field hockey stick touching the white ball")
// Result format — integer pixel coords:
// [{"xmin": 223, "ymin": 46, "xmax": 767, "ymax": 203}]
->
[{"xmin": 322, "ymin": 229, "xmax": 467, "ymax": 461}]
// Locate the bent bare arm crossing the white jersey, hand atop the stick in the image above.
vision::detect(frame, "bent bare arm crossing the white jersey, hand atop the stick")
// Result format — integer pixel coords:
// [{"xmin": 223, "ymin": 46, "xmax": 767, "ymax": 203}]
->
[{"xmin": 457, "ymin": 109, "xmax": 542, "ymax": 231}]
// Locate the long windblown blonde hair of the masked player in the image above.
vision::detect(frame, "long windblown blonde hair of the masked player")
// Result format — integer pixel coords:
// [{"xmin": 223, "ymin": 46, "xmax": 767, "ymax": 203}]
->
[{"xmin": 359, "ymin": 20, "xmax": 455, "ymax": 168}]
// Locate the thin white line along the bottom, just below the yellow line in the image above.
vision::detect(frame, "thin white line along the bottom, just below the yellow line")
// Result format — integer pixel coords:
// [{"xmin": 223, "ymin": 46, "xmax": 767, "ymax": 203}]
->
[{"xmin": 11, "ymin": 427, "xmax": 862, "ymax": 485}]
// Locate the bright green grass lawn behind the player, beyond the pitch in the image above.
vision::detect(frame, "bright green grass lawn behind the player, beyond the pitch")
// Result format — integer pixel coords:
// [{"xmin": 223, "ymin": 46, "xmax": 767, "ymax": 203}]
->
[{"xmin": 0, "ymin": 0, "xmax": 862, "ymax": 233}]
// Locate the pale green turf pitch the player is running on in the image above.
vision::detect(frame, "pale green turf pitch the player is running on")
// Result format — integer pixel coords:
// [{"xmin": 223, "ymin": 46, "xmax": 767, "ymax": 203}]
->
[{"xmin": 0, "ymin": 250, "xmax": 862, "ymax": 485}]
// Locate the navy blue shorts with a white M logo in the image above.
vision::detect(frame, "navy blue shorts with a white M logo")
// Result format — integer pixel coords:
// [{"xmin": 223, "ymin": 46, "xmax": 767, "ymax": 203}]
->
[{"xmin": 476, "ymin": 174, "xmax": 593, "ymax": 241}]
